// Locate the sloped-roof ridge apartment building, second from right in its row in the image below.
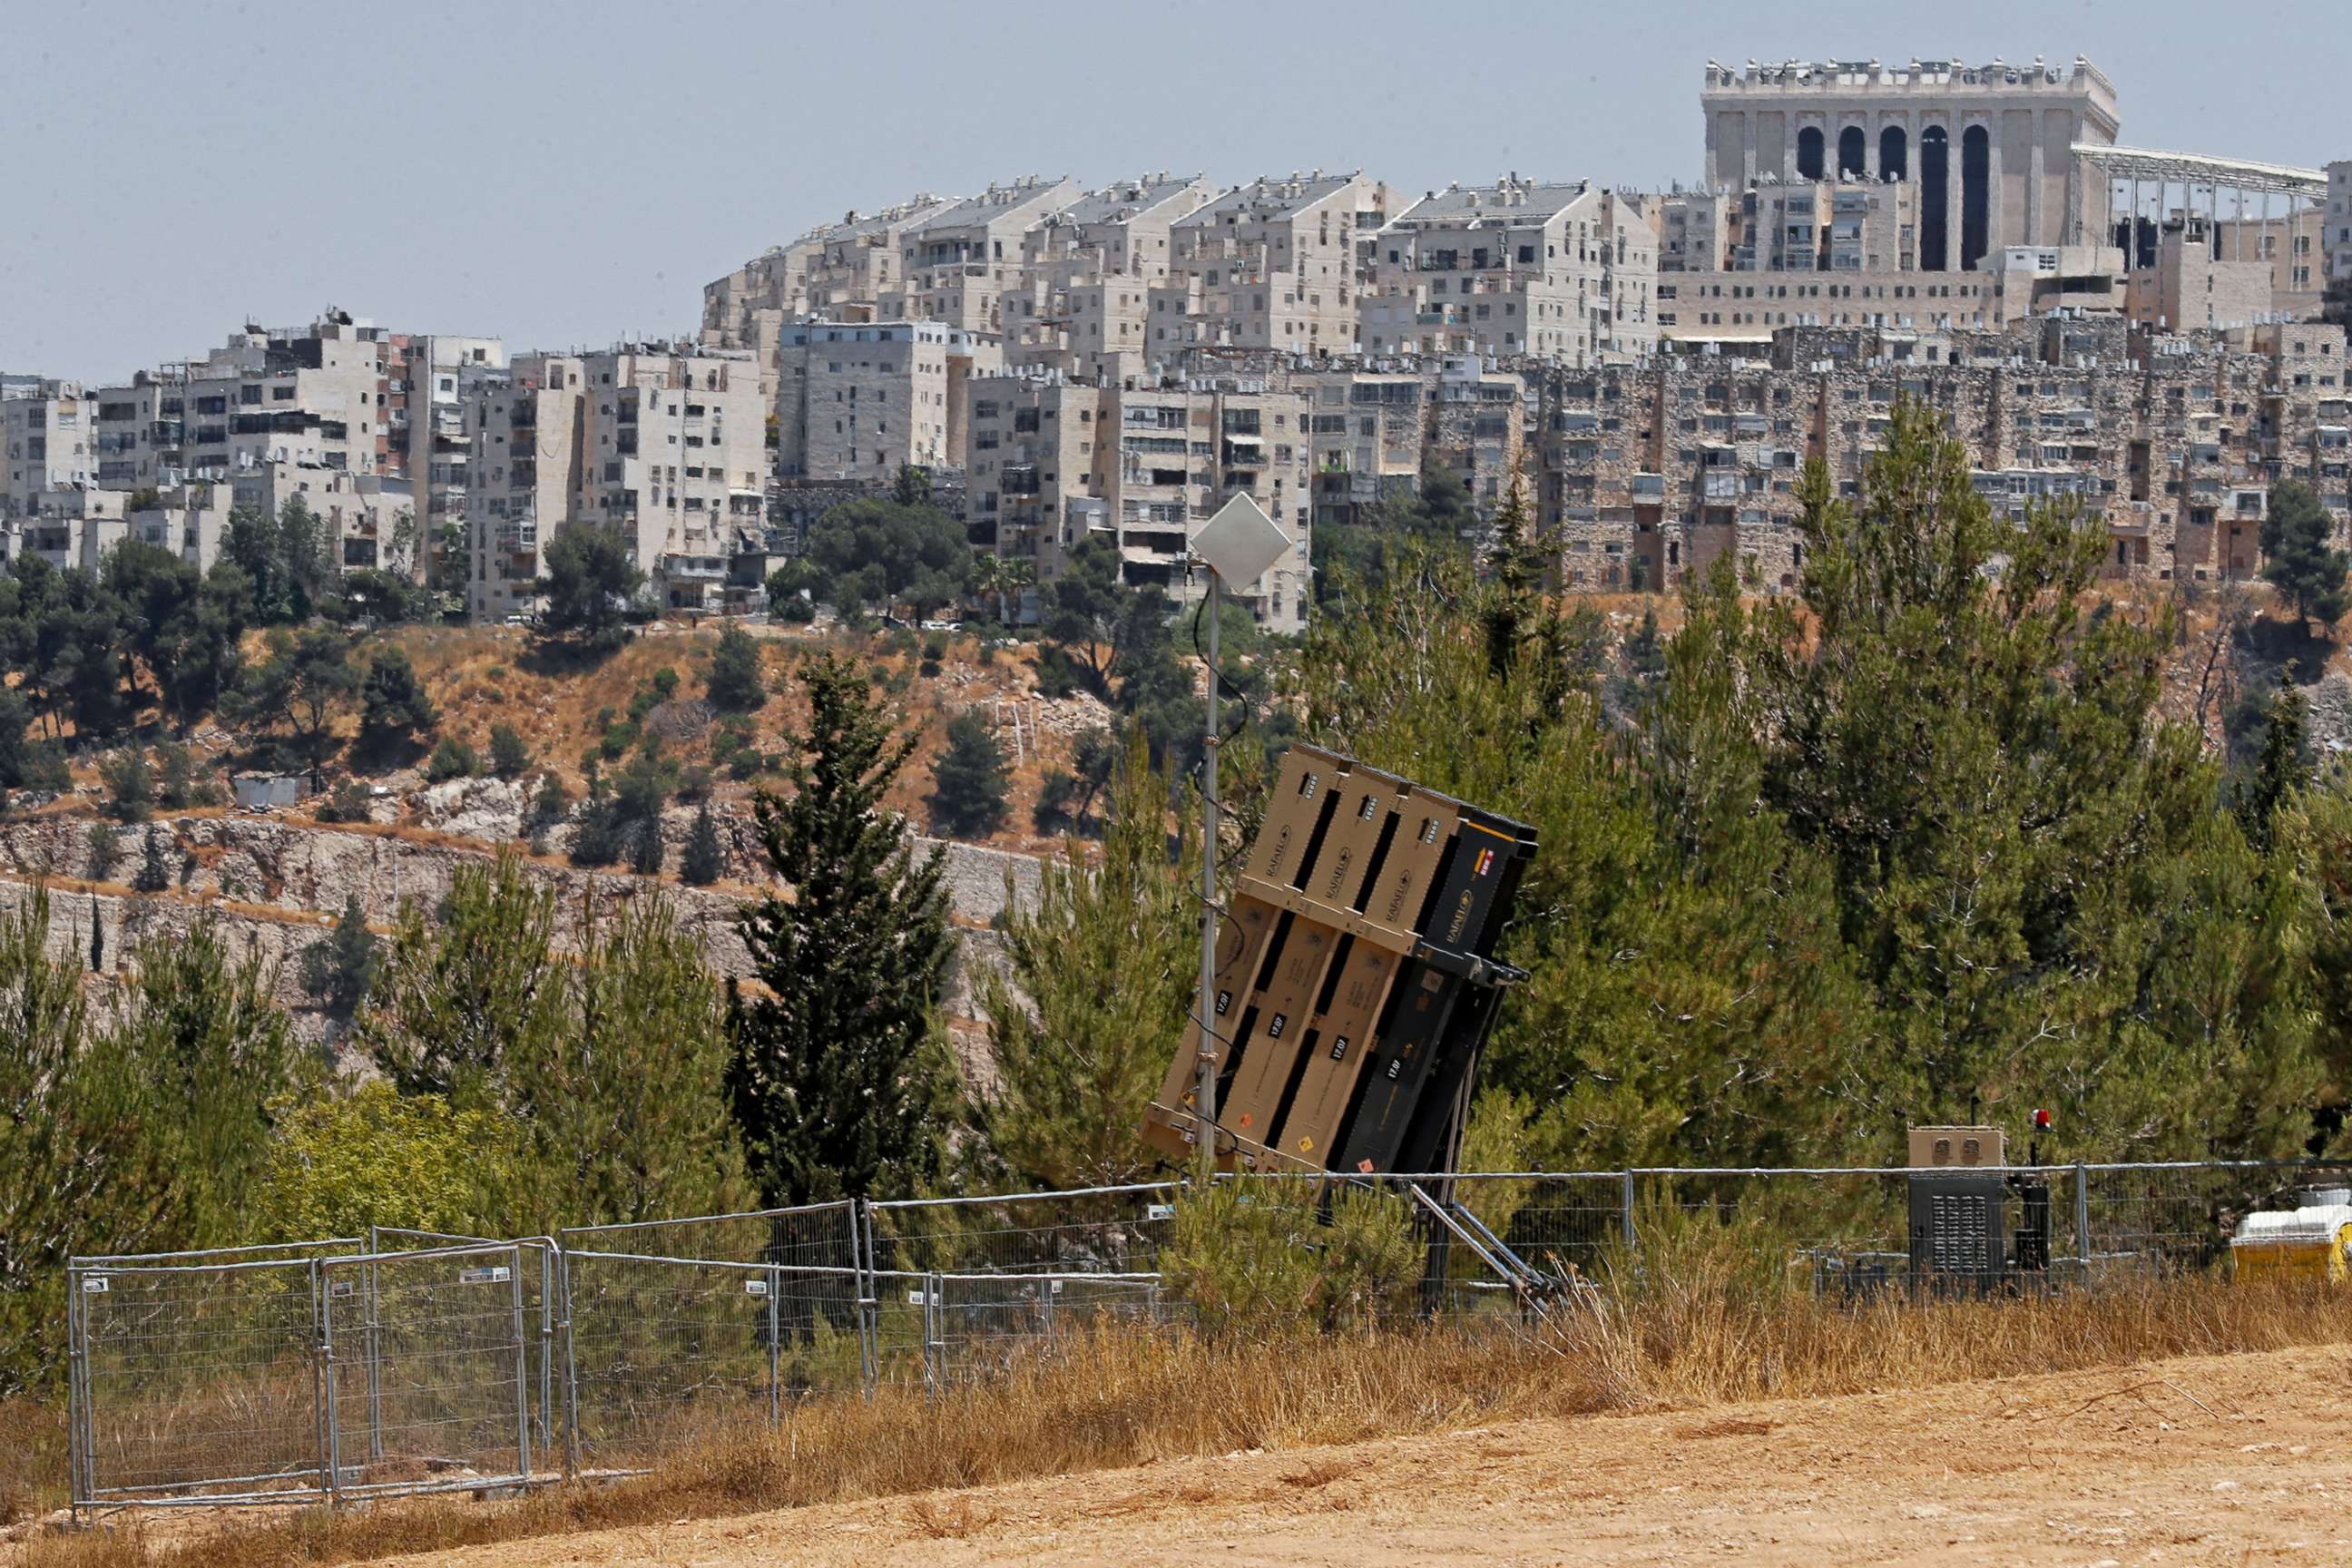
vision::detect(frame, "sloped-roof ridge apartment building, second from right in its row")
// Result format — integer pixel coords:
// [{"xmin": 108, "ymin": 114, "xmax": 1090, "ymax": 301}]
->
[{"xmin": 1150, "ymin": 170, "xmax": 1395, "ymax": 359}]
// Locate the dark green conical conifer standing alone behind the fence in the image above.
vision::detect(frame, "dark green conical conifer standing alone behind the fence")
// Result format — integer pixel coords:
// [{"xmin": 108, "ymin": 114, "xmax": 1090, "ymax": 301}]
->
[{"xmin": 730, "ymin": 653, "xmax": 953, "ymax": 1203}]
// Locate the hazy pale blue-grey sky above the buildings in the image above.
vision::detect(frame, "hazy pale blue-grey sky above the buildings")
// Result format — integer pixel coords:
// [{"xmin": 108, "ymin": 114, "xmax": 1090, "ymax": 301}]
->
[{"xmin": 0, "ymin": 0, "xmax": 2352, "ymax": 381}]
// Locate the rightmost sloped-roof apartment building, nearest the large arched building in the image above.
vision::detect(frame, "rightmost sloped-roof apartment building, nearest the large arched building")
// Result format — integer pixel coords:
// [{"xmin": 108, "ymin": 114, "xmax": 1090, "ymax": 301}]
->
[{"xmin": 1362, "ymin": 174, "xmax": 1658, "ymax": 365}]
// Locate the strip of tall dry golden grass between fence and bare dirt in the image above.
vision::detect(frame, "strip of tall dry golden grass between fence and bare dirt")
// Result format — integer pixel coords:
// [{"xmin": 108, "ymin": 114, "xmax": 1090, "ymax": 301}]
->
[{"xmin": 21, "ymin": 1272, "xmax": 2352, "ymax": 1568}]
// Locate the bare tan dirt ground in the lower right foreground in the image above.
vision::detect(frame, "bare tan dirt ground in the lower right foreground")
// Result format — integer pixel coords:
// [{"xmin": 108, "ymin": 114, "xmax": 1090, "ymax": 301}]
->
[{"xmin": 380, "ymin": 1347, "xmax": 2352, "ymax": 1568}]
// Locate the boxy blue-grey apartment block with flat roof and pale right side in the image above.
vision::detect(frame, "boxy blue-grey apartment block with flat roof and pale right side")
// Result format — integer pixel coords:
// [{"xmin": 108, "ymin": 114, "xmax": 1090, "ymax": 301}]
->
[{"xmin": 776, "ymin": 322, "xmax": 1004, "ymax": 482}]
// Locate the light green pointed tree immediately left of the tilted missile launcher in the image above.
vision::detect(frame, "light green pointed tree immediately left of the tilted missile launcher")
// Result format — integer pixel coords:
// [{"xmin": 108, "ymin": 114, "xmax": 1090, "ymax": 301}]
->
[{"xmin": 971, "ymin": 736, "xmax": 1200, "ymax": 1187}]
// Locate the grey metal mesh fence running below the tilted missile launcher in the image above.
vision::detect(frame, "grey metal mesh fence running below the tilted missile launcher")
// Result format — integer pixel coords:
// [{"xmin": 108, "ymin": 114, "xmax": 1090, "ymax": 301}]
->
[{"xmin": 68, "ymin": 1161, "xmax": 2352, "ymax": 1507}]
